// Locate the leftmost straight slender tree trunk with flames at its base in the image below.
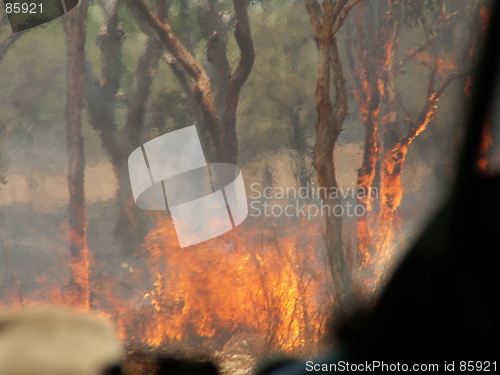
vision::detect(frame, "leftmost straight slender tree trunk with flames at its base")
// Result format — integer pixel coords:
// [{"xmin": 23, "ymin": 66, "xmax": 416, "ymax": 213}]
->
[{"xmin": 64, "ymin": 0, "xmax": 90, "ymax": 309}]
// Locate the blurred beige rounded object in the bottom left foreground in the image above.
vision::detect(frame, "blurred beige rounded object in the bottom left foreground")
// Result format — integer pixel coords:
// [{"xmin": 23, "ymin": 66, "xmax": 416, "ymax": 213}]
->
[{"xmin": 0, "ymin": 308, "xmax": 122, "ymax": 375}]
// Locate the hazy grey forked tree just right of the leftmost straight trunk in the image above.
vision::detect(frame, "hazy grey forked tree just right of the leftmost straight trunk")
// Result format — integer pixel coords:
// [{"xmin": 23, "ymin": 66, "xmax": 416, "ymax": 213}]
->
[{"xmin": 86, "ymin": 0, "xmax": 164, "ymax": 255}]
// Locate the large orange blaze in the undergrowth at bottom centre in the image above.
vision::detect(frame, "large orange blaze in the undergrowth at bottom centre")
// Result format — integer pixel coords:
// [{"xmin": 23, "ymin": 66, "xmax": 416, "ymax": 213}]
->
[{"xmin": 105, "ymin": 217, "xmax": 329, "ymax": 351}]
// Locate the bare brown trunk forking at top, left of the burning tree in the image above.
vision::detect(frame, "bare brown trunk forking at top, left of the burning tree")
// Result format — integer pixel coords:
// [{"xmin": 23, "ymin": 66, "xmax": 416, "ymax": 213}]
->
[{"xmin": 306, "ymin": 0, "xmax": 356, "ymax": 315}]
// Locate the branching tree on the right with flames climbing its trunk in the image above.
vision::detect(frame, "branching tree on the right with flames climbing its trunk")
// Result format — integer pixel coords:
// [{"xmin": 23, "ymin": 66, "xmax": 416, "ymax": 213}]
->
[{"xmin": 347, "ymin": 0, "xmax": 478, "ymax": 295}]
